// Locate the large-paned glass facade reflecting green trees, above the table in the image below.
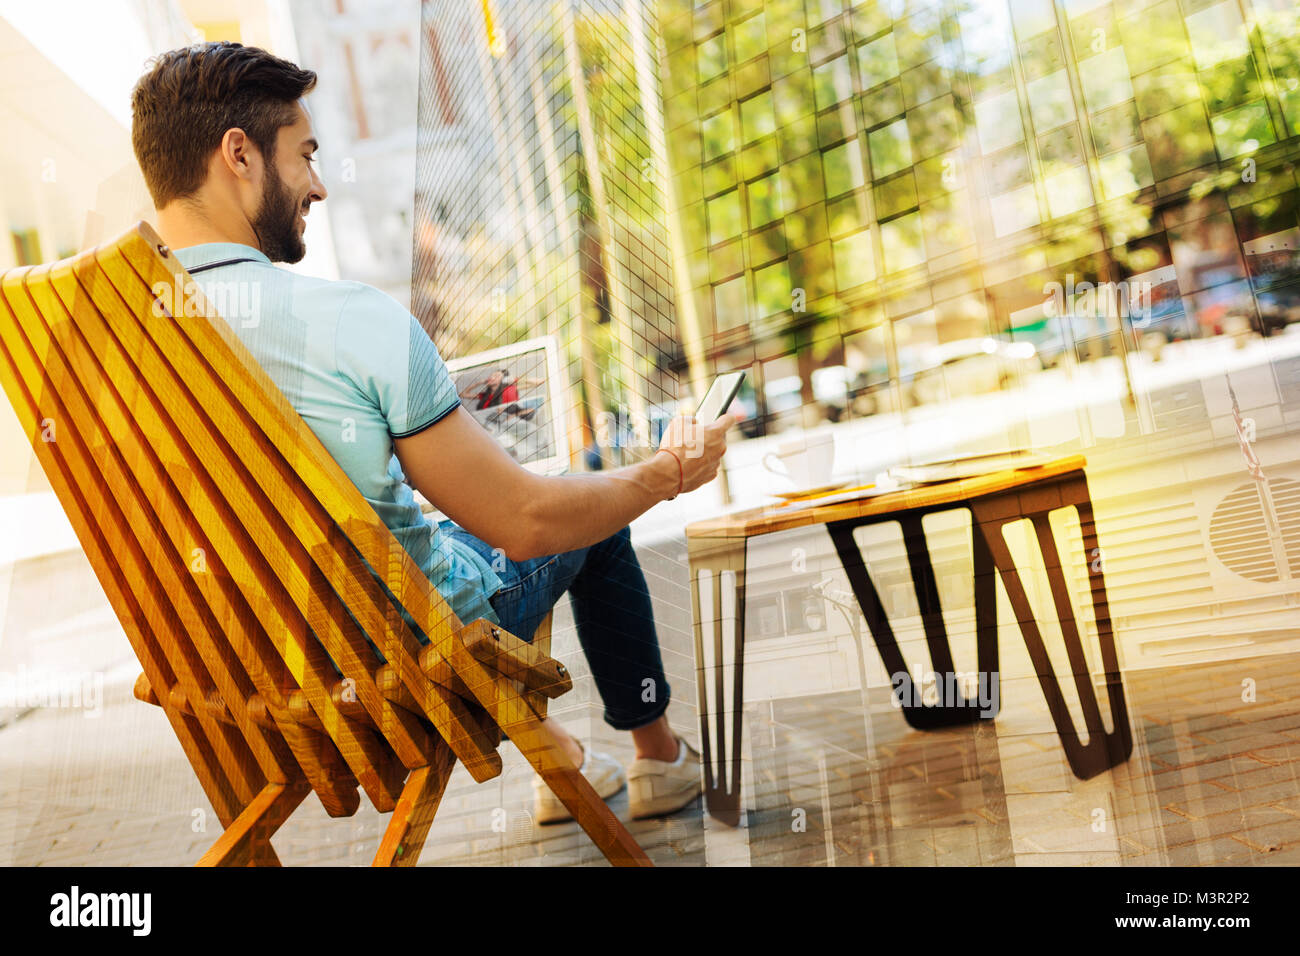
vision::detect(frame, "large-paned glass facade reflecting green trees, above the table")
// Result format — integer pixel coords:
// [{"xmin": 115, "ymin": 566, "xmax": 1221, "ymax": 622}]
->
[{"xmin": 659, "ymin": 0, "xmax": 1300, "ymax": 451}]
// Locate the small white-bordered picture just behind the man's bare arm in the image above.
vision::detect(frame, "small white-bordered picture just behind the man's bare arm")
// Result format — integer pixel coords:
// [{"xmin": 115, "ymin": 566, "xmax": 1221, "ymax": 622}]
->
[{"xmin": 447, "ymin": 336, "xmax": 569, "ymax": 475}]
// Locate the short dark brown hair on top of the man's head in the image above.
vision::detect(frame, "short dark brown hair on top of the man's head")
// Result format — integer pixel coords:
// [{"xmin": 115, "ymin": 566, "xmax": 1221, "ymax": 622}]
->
[{"xmin": 131, "ymin": 42, "xmax": 316, "ymax": 208}]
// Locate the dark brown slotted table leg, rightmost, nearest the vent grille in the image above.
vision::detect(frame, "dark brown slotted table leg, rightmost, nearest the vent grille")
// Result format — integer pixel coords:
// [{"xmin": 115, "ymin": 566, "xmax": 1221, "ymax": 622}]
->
[{"xmin": 971, "ymin": 484, "xmax": 1132, "ymax": 780}]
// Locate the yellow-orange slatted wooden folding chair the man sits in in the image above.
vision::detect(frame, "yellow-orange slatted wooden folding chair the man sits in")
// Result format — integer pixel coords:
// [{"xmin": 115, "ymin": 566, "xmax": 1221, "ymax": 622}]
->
[{"xmin": 0, "ymin": 222, "xmax": 650, "ymax": 866}]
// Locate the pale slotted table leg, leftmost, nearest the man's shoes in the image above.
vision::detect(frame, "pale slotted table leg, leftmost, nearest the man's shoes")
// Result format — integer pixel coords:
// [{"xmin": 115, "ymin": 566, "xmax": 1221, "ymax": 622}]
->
[{"xmin": 686, "ymin": 538, "xmax": 745, "ymax": 826}]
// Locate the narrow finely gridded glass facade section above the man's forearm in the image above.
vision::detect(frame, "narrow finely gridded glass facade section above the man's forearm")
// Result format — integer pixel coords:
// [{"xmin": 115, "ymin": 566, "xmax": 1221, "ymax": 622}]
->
[{"xmin": 412, "ymin": 0, "xmax": 681, "ymax": 468}]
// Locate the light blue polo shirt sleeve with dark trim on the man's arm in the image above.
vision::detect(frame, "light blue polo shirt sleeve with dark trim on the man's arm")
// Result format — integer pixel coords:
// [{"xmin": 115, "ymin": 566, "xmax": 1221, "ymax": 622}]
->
[{"xmin": 337, "ymin": 284, "xmax": 460, "ymax": 438}]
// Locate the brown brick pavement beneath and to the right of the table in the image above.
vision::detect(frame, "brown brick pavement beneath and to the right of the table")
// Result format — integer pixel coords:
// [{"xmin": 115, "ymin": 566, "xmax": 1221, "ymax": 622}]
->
[{"xmin": 749, "ymin": 656, "xmax": 1300, "ymax": 866}]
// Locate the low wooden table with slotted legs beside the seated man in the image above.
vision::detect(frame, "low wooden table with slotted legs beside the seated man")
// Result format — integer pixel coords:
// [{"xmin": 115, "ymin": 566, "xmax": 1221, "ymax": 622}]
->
[{"xmin": 686, "ymin": 455, "xmax": 1132, "ymax": 826}]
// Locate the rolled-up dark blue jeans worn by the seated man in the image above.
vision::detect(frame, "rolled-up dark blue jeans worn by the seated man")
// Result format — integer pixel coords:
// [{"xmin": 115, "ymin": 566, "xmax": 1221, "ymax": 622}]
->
[{"xmin": 442, "ymin": 523, "xmax": 670, "ymax": 730}]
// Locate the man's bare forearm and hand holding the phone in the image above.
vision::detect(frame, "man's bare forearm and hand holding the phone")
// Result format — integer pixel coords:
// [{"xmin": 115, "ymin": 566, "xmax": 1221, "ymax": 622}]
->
[{"xmin": 394, "ymin": 407, "xmax": 733, "ymax": 561}]
